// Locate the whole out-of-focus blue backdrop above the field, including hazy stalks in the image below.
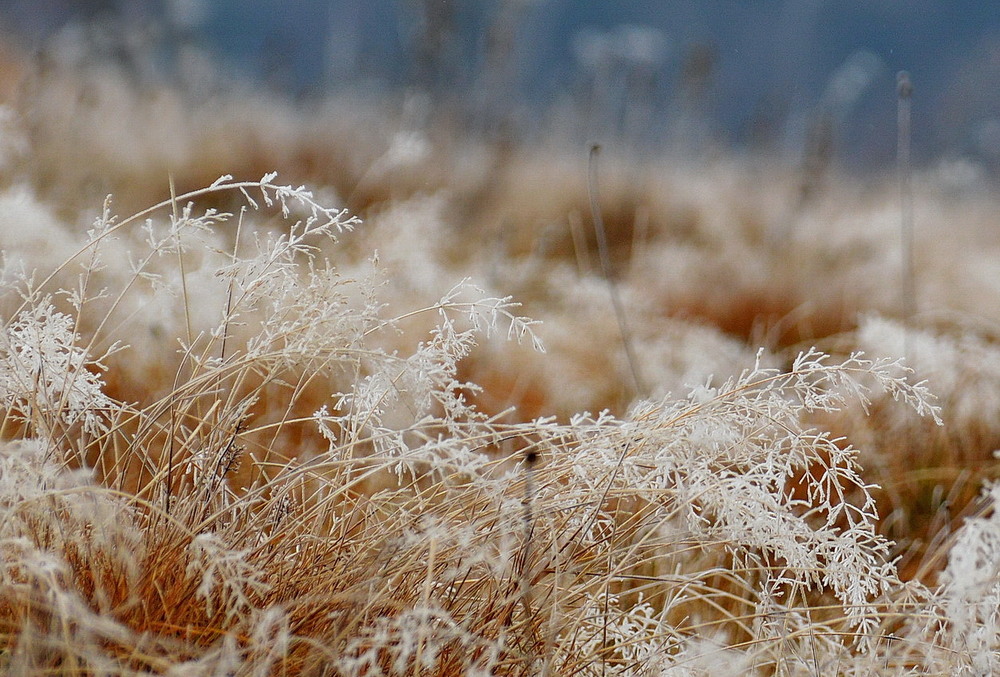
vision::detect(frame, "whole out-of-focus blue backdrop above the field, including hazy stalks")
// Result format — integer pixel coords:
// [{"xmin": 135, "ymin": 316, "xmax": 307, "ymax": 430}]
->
[{"xmin": 0, "ymin": 0, "xmax": 1000, "ymax": 174}]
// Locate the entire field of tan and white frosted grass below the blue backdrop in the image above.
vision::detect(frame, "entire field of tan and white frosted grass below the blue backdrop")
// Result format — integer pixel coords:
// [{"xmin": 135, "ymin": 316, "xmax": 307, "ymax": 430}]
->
[{"xmin": 0, "ymin": 50, "xmax": 1000, "ymax": 677}]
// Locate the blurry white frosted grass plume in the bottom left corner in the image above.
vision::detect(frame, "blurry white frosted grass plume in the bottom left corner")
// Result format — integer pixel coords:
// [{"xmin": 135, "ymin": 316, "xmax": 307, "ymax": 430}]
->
[{"xmin": 0, "ymin": 440, "xmax": 144, "ymax": 674}]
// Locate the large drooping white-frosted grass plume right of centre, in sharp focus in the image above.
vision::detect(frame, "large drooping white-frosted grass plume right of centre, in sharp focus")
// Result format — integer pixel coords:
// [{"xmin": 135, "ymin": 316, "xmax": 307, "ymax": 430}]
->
[{"xmin": 556, "ymin": 352, "xmax": 935, "ymax": 664}]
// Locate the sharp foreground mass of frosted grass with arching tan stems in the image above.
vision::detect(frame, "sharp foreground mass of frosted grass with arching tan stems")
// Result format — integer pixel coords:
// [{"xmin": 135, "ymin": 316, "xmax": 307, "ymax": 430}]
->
[{"xmin": 0, "ymin": 174, "xmax": 984, "ymax": 675}]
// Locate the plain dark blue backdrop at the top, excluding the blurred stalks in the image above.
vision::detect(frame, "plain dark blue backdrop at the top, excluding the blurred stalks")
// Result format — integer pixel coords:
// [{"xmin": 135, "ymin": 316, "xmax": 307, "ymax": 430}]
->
[{"xmin": 0, "ymin": 0, "xmax": 1000, "ymax": 167}]
